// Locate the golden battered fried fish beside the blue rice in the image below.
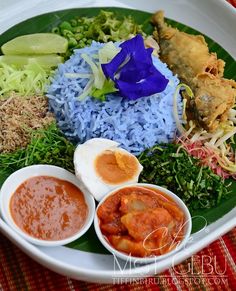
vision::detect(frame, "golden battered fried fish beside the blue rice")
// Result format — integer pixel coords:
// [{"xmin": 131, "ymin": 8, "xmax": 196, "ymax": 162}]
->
[{"xmin": 152, "ymin": 11, "xmax": 236, "ymax": 131}]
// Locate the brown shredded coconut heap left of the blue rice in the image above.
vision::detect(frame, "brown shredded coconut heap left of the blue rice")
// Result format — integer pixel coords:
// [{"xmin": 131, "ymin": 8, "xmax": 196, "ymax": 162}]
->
[{"xmin": 0, "ymin": 94, "xmax": 54, "ymax": 153}]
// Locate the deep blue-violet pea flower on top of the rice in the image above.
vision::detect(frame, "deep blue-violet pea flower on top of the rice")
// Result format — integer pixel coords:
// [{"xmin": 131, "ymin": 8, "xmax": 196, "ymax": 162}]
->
[{"xmin": 102, "ymin": 34, "xmax": 168, "ymax": 100}]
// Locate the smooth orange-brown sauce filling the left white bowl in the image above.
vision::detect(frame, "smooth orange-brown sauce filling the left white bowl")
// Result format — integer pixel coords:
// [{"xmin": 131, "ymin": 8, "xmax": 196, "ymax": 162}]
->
[{"xmin": 10, "ymin": 176, "xmax": 88, "ymax": 240}]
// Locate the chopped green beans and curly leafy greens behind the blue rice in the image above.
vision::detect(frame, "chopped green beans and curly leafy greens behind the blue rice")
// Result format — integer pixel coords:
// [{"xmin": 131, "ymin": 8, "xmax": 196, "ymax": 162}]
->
[{"xmin": 52, "ymin": 10, "xmax": 145, "ymax": 56}]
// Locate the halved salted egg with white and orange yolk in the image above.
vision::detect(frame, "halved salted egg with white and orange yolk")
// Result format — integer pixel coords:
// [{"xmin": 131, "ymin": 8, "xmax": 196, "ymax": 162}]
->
[{"xmin": 74, "ymin": 138, "xmax": 143, "ymax": 201}]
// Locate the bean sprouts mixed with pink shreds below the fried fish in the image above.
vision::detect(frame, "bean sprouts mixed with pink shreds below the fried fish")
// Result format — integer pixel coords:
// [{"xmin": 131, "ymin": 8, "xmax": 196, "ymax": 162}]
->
[{"xmin": 173, "ymin": 83, "xmax": 236, "ymax": 179}]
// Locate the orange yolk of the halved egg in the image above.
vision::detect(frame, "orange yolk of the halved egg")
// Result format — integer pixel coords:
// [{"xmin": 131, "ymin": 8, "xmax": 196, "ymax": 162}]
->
[{"xmin": 95, "ymin": 150, "xmax": 138, "ymax": 184}]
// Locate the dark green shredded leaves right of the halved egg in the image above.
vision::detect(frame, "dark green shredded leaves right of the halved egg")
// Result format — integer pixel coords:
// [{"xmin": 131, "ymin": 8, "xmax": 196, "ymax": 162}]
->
[{"xmin": 139, "ymin": 144, "xmax": 229, "ymax": 211}]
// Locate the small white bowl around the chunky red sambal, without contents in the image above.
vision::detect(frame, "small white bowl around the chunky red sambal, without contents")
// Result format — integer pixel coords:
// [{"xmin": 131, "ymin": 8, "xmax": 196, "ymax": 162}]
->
[{"xmin": 94, "ymin": 183, "xmax": 192, "ymax": 264}]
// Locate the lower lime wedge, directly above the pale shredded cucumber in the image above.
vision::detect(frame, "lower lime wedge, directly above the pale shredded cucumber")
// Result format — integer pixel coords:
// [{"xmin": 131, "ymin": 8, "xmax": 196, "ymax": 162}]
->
[{"xmin": 0, "ymin": 54, "xmax": 64, "ymax": 68}]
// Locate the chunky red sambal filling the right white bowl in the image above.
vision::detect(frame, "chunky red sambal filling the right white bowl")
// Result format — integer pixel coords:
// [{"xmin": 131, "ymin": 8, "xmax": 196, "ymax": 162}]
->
[{"xmin": 97, "ymin": 186, "xmax": 185, "ymax": 257}]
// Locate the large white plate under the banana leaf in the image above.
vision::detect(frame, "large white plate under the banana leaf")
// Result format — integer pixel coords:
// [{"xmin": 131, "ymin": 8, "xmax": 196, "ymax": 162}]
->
[{"xmin": 0, "ymin": 0, "xmax": 236, "ymax": 283}]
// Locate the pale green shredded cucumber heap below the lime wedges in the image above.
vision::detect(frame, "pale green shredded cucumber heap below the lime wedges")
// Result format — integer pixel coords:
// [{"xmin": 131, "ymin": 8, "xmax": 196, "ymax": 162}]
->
[{"xmin": 0, "ymin": 61, "xmax": 51, "ymax": 98}]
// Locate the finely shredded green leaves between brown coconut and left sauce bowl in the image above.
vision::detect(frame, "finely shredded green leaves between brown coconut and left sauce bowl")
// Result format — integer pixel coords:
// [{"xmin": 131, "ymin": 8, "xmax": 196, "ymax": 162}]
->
[{"xmin": 0, "ymin": 123, "xmax": 75, "ymax": 176}]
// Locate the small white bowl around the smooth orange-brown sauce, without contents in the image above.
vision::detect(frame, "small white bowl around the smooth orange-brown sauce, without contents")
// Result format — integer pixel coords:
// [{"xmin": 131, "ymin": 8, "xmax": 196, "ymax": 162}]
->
[{"xmin": 0, "ymin": 165, "xmax": 95, "ymax": 247}]
